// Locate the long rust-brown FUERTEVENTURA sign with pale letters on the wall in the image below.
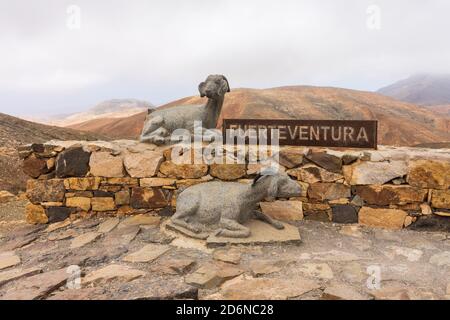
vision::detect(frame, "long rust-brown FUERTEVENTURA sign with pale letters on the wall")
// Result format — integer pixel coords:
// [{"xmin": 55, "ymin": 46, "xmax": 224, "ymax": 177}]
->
[{"xmin": 223, "ymin": 119, "xmax": 378, "ymax": 149}]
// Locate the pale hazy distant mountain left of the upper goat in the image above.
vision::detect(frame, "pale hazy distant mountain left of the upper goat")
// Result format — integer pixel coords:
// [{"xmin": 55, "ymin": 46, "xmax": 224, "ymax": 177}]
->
[{"xmin": 37, "ymin": 99, "xmax": 153, "ymax": 127}]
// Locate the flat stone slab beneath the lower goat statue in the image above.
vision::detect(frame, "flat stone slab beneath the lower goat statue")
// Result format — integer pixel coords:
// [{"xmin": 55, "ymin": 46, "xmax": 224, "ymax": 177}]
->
[{"xmin": 206, "ymin": 220, "xmax": 301, "ymax": 247}]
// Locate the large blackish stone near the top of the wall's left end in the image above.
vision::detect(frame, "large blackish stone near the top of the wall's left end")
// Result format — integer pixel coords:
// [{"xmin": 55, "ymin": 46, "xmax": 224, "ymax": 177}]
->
[{"xmin": 56, "ymin": 147, "xmax": 91, "ymax": 178}]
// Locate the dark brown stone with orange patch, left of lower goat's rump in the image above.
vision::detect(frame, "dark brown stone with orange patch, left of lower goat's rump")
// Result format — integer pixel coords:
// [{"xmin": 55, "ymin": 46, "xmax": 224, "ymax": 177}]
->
[{"xmin": 130, "ymin": 187, "xmax": 170, "ymax": 209}]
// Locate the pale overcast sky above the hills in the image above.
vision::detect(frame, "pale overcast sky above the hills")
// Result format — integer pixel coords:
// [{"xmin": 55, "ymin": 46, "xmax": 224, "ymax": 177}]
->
[{"xmin": 0, "ymin": 0, "xmax": 450, "ymax": 116}]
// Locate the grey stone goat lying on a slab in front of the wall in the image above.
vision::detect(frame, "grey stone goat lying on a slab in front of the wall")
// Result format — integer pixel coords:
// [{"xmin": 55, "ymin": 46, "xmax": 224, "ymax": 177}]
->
[{"xmin": 171, "ymin": 173, "xmax": 301, "ymax": 239}]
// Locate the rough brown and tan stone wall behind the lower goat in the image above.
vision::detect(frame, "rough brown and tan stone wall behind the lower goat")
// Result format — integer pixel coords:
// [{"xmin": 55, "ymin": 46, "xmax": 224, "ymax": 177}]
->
[{"xmin": 18, "ymin": 140, "xmax": 450, "ymax": 229}]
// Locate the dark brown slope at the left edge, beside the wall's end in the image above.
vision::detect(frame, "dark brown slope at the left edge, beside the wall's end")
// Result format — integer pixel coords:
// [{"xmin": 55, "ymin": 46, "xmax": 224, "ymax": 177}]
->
[{"xmin": 0, "ymin": 113, "xmax": 108, "ymax": 192}]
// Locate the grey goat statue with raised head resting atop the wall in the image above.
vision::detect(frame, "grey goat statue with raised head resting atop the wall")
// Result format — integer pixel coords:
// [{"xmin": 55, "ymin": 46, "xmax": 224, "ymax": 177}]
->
[{"xmin": 140, "ymin": 75, "xmax": 230, "ymax": 145}]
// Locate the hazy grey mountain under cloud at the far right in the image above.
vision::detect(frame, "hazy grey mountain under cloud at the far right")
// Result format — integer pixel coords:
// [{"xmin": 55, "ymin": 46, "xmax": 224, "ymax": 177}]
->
[{"xmin": 378, "ymin": 74, "xmax": 450, "ymax": 106}]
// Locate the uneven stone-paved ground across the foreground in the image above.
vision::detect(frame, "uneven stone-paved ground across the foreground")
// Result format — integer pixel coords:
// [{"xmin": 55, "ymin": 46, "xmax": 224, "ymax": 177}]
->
[{"xmin": 0, "ymin": 201, "xmax": 450, "ymax": 299}]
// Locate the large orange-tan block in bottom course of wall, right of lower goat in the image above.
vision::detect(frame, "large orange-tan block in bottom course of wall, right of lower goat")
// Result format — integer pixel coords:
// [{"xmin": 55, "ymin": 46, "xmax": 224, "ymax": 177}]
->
[{"xmin": 359, "ymin": 207, "xmax": 407, "ymax": 230}]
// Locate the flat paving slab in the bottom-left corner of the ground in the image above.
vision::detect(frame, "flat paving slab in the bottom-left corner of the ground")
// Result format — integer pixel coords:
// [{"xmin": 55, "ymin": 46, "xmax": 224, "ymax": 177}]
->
[{"xmin": 1, "ymin": 268, "xmax": 70, "ymax": 300}]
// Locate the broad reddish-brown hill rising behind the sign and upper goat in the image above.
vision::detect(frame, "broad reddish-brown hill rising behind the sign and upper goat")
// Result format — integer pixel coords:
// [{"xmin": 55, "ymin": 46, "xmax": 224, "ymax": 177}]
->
[{"xmin": 69, "ymin": 86, "xmax": 450, "ymax": 146}]
